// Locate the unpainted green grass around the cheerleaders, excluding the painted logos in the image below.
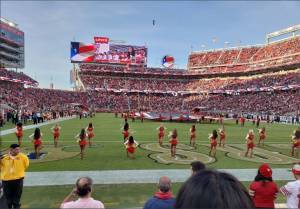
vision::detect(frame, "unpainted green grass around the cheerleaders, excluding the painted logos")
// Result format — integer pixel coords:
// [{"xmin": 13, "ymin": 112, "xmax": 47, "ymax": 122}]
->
[{"xmin": 2, "ymin": 113, "xmax": 297, "ymax": 171}]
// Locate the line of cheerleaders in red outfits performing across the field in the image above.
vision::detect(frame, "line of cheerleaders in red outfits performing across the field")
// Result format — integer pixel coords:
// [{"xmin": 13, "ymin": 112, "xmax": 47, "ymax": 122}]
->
[{"xmin": 15, "ymin": 120, "xmax": 300, "ymax": 159}]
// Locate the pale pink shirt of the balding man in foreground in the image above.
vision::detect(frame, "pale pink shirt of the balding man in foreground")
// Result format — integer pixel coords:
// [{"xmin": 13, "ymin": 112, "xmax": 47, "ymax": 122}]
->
[{"xmin": 60, "ymin": 197, "xmax": 104, "ymax": 208}]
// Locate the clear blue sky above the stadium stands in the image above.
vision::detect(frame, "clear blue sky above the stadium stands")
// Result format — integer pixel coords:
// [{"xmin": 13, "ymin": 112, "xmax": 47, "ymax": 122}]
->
[{"xmin": 0, "ymin": 1, "xmax": 300, "ymax": 89}]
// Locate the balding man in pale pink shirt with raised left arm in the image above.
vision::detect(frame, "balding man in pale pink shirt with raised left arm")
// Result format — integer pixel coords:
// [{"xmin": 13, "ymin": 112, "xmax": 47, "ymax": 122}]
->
[{"xmin": 60, "ymin": 177, "xmax": 104, "ymax": 208}]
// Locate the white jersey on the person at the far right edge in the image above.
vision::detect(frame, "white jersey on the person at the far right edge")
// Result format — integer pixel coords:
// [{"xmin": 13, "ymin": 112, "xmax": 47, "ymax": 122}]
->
[{"xmin": 280, "ymin": 180, "xmax": 300, "ymax": 208}]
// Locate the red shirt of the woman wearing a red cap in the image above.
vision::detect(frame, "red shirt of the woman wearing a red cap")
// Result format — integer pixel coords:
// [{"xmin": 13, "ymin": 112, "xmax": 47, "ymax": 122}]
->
[{"xmin": 250, "ymin": 181, "xmax": 278, "ymax": 208}]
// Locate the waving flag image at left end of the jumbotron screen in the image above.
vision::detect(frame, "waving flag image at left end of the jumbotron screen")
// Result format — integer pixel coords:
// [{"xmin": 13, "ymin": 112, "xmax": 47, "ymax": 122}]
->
[{"xmin": 71, "ymin": 42, "xmax": 95, "ymax": 62}]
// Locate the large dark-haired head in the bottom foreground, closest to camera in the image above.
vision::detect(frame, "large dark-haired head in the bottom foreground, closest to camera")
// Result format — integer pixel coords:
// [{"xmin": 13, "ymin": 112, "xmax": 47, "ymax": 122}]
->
[{"xmin": 174, "ymin": 170, "xmax": 254, "ymax": 209}]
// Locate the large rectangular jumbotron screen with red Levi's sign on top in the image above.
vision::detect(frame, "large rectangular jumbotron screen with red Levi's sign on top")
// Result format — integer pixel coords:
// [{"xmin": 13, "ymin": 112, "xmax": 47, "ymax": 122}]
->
[{"xmin": 71, "ymin": 37, "xmax": 147, "ymax": 66}]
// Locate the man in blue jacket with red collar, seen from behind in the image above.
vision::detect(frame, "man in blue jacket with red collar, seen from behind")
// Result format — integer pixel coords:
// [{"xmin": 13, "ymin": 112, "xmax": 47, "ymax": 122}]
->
[{"xmin": 144, "ymin": 176, "xmax": 175, "ymax": 209}]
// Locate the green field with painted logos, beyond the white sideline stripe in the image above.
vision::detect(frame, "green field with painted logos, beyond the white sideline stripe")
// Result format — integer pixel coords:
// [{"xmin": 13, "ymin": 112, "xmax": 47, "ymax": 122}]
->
[{"xmin": 2, "ymin": 113, "xmax": 297, "ymax": 171}]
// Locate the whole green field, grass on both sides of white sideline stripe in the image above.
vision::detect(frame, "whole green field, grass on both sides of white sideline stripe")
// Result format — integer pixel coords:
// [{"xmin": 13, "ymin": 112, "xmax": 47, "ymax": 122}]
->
[{"xmin": 1, "ymin": 113, "xmax": 299, "ymax": 208}]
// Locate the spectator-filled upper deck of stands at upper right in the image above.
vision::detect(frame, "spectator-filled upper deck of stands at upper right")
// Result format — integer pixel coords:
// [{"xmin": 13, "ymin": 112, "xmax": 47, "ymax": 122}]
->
[{"xmin": 189, "ymin": 37, "xmax": 300, "ymax": 74}]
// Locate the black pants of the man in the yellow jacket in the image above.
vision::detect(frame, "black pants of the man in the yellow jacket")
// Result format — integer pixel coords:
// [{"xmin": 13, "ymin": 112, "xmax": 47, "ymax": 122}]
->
[{"xmin": 2, "ymin": 178, "xmax": 23, "ymax": 208}]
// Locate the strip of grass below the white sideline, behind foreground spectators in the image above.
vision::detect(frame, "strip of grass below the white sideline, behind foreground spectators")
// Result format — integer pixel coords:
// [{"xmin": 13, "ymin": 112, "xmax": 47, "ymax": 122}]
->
[{"xmin": 21, "ymin": 181, "xmax": 286, "ymax": 208}]
